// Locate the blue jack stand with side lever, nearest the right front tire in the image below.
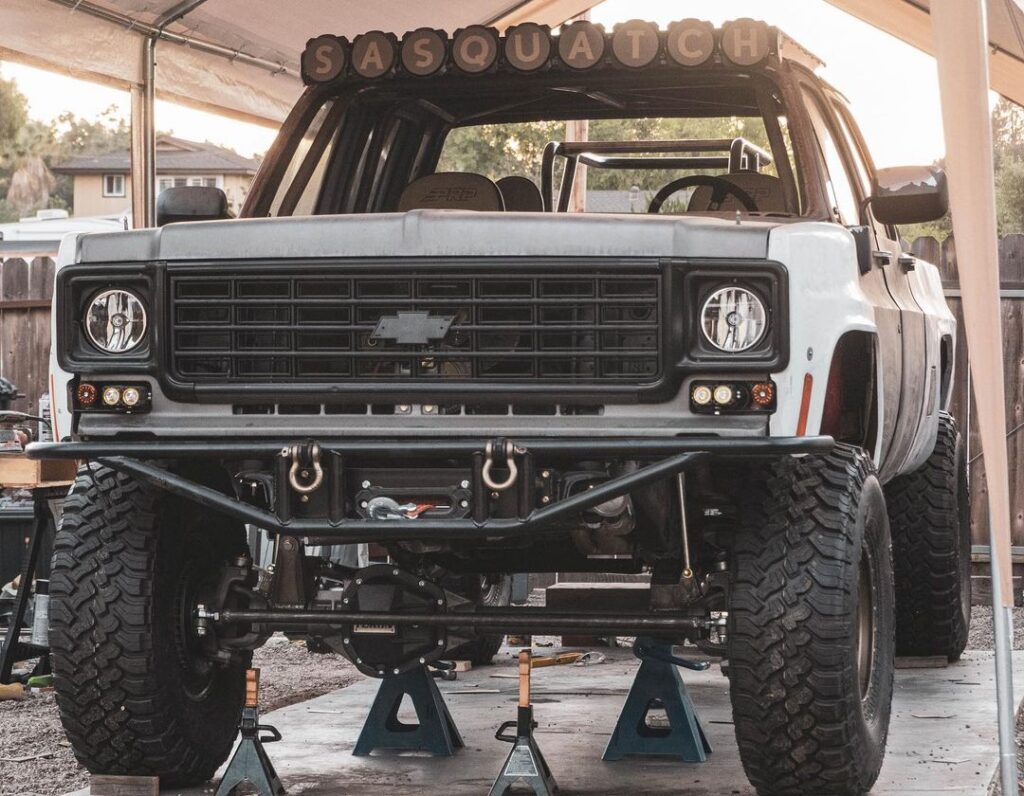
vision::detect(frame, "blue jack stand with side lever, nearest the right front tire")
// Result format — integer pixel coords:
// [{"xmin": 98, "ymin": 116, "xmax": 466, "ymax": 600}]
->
[{"xmin": 602, "ymin": 638, "xmax": 711, "ymax": 763}]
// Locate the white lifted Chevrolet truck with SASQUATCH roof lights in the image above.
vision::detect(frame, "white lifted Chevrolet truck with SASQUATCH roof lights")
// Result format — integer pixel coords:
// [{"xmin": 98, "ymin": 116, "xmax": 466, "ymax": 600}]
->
[{"xmin": 31, "ymin": 19, "xmax": 970, "ymax": 796}]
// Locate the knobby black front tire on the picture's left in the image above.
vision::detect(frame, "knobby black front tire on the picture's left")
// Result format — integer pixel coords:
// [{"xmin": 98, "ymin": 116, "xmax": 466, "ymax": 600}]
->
[{"xmin": 50, "ymin": 465, "xmax": 244, "ymax": 786}]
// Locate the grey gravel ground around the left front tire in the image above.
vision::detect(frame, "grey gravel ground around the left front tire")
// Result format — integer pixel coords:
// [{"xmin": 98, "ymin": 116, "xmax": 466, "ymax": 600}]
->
[{"xmin": 0, "ymin": 636, "xmax": 362, "ymax": 796}]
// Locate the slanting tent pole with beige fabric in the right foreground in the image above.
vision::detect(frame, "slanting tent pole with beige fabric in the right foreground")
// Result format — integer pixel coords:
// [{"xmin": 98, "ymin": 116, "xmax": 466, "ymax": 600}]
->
[{"xmin": 931, "ymin": 0, "xmax": 1017, "ymax": 796}]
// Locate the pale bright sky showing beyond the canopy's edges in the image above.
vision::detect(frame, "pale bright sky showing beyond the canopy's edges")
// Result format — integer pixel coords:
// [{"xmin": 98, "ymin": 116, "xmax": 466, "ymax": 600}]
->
[{"xmin": 0, "ymin": 0, "xmax": 966, "ymax": 166}]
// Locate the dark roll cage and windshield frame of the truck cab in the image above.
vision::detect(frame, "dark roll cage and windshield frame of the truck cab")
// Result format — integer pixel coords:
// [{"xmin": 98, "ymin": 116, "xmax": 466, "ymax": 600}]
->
[{"xmin": 242, "ymin": 60, "xmax": 831, "ymax": 219}]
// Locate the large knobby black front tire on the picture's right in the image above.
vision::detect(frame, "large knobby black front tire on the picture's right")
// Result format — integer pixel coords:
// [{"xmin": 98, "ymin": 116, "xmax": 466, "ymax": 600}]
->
[{"xmin": 727, "ymin": 446, "xmax": 894, "ymax": 796}]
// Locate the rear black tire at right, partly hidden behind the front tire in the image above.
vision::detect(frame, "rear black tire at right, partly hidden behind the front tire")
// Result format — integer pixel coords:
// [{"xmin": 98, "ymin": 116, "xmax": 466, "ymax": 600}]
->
[{"xmin": 886, "ymin": 412, "xmax": 971, "ymax": 662}]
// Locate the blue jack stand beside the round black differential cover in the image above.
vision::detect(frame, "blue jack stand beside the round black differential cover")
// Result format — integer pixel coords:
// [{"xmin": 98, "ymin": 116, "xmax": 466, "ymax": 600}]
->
[{"xmin": 352, "ymin": 666, "xmax": 465, "ymax": 757}]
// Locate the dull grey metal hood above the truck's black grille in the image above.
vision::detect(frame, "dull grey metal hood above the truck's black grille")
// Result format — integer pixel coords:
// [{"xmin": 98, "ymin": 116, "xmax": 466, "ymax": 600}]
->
[{"xmin": 75, "ymin": 210, "xmax": 774, "ymax": 262}]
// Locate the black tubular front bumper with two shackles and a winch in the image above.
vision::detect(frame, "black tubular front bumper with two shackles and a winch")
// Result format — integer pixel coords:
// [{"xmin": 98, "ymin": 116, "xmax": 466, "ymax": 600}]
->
[{"xmin": 27, "ymin": 436, "xmax": 835, "ymax": 543}]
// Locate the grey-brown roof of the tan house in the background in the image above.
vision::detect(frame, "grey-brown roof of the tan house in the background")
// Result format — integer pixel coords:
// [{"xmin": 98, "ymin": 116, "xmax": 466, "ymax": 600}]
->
[{"xmin": 51, "ymin": 135, "xmax": 259, "ymax": 174}]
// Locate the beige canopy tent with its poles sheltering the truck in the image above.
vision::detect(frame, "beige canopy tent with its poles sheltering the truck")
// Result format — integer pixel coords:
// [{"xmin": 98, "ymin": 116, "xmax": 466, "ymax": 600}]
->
[{"xmin": 0, "ymin": 0, "xmax": 1024, "ymax": 793}]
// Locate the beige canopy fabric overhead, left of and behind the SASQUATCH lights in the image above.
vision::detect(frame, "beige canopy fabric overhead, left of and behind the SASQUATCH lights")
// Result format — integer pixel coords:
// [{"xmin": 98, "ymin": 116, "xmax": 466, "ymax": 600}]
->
[{"xmin": 0, "ymin": 0, "xmax": 597, "ymax": 125}]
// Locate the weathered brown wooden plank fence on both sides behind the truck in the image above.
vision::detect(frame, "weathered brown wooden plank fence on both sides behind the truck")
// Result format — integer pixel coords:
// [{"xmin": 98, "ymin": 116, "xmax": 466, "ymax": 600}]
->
[{"xmin": 0, "ymin": 235, "xmax": 1024, "ymax": 591}]
